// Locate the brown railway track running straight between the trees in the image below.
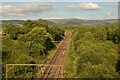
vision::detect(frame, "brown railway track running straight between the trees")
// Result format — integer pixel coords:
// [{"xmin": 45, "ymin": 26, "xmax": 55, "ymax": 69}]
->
[{"xmin": 40, "ymin": 32, "xmax": 71, "ymax": 80}]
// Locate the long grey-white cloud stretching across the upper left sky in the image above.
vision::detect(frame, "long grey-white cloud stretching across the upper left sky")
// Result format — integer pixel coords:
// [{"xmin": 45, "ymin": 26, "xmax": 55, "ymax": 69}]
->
[{"xmin": 0, "ymin": 3, "xmax": 55, "ymax": 16}]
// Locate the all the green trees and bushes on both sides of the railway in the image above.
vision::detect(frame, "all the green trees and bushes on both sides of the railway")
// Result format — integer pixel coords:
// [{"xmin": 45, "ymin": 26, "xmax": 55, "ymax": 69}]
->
[{"xmin": 2, "ymin": 19, "xmax": 120, "ymax": 78}]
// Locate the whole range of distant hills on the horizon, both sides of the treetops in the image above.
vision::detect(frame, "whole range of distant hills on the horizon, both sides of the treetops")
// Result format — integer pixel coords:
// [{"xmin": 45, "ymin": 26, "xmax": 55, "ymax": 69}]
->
[{"xmin": 0, "ymin": 18, "xmax": 118, "ymax": 25}]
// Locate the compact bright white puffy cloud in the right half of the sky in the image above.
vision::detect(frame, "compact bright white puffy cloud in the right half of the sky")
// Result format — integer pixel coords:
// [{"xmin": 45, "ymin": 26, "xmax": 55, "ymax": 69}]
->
[{"xmin": 66, "ymin": 2, "xmax": 100, "ymax": 10}]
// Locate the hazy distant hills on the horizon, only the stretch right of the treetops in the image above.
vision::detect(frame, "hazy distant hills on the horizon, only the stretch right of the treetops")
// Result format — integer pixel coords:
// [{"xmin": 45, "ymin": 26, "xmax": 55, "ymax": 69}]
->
[{"xmin": 47, "ymin": 19, "xmax": 118, "ymax": 25}]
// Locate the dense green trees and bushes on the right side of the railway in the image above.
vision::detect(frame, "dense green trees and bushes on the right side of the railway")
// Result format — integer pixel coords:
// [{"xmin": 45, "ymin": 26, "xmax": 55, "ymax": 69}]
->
[{"xmin": 65, "ymin": 24, "xmax": 120, "ymax": 78}]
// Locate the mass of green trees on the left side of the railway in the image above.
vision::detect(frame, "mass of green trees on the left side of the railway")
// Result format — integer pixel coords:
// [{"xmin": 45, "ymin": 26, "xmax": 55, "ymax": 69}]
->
[{"xmin": 2, "ymin": 19, "xmax": 65, "ymax": 78}]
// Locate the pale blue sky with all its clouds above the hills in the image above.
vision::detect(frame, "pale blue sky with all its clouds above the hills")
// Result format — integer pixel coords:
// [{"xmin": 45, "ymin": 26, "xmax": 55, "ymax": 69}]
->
[{"xmin": 0, "ymin": 2, "xmax": 118, "ymax": 20}]
